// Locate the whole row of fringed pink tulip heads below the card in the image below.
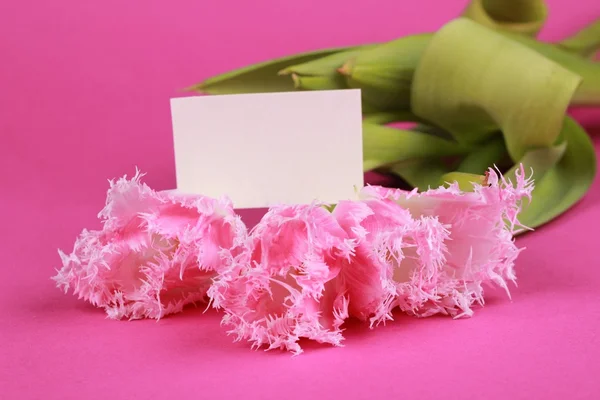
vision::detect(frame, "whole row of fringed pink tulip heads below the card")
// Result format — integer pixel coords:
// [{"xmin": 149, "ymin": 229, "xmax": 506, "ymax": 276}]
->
[{"xmin": 54, "ymin": 167, "xmax": 533, "ymax": 354}]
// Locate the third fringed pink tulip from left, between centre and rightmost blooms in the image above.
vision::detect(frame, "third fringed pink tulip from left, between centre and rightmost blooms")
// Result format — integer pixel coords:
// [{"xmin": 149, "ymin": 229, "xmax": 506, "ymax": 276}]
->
[{"xmin": 334, "ymin": 198, "xmax": 448, "ymax": 325}]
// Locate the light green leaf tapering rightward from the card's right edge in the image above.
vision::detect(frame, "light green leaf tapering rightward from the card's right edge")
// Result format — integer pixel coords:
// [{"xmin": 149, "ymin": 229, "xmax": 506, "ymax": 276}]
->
[{"xmin": 363, "ymin": 122, "xmax": 469, "ymax": 171}]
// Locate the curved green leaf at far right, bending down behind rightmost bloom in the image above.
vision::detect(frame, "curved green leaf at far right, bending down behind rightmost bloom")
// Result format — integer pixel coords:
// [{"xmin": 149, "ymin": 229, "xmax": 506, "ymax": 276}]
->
[{"xmin": 506, "ymin": 117, "xmax": 597, "ymax": 228}]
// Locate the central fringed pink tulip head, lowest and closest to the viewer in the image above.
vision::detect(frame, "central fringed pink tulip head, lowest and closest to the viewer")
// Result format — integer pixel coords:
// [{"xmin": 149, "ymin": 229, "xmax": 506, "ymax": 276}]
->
[{"xmin": 209, "ymin": 205, "xmax": 354, "ymax": 354}]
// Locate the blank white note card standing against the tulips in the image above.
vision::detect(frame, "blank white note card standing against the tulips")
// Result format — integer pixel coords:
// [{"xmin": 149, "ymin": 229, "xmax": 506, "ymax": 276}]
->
[{"xmin": 171, "ymin": 89, "xmax": 364, "ymax": 208}]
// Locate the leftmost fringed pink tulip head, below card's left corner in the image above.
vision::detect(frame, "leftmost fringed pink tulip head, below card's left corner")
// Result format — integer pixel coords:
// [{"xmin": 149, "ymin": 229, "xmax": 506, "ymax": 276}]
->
[{"xmin": 53, "ymin": 173, "xmax": 246, "ymax": 319}]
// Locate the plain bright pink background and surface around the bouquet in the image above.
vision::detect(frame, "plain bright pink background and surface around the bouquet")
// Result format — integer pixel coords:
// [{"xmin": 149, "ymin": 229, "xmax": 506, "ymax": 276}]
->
[{"xmin": 0, "ymin": 0, "xmax": 600, "ymax": 399}]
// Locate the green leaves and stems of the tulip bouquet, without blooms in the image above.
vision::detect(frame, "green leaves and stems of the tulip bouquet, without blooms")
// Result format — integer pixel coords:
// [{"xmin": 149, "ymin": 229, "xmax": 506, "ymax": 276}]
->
[{"xmin": 191, "ymin": 0, "xmax": 600, "ymax": 228}]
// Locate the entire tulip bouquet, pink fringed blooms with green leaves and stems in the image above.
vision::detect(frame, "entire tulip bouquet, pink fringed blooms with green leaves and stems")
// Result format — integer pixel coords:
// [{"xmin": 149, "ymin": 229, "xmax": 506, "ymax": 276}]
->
[{"xmin": 54, "ymin": 0, "xmax": 600, "ymax": 354}]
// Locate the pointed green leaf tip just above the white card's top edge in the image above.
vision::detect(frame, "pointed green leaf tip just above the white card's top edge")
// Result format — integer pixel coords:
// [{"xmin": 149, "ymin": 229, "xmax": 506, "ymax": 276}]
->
[{"xmin": 188, "ymin": 47, "xmax": 351, "ymax": 94}]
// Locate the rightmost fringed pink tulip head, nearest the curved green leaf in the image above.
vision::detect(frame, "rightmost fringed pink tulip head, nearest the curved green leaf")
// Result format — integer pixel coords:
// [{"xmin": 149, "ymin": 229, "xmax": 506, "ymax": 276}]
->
[{"xmin": 361, "ymin": 167, "xmax": 533, "ymax": 318}]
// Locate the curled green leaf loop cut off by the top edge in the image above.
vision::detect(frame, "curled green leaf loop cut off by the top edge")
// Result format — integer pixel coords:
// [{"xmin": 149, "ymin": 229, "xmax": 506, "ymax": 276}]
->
[{"xmin": 463, "ymin": 0, "xmax": 548, "ymax": 36}]
